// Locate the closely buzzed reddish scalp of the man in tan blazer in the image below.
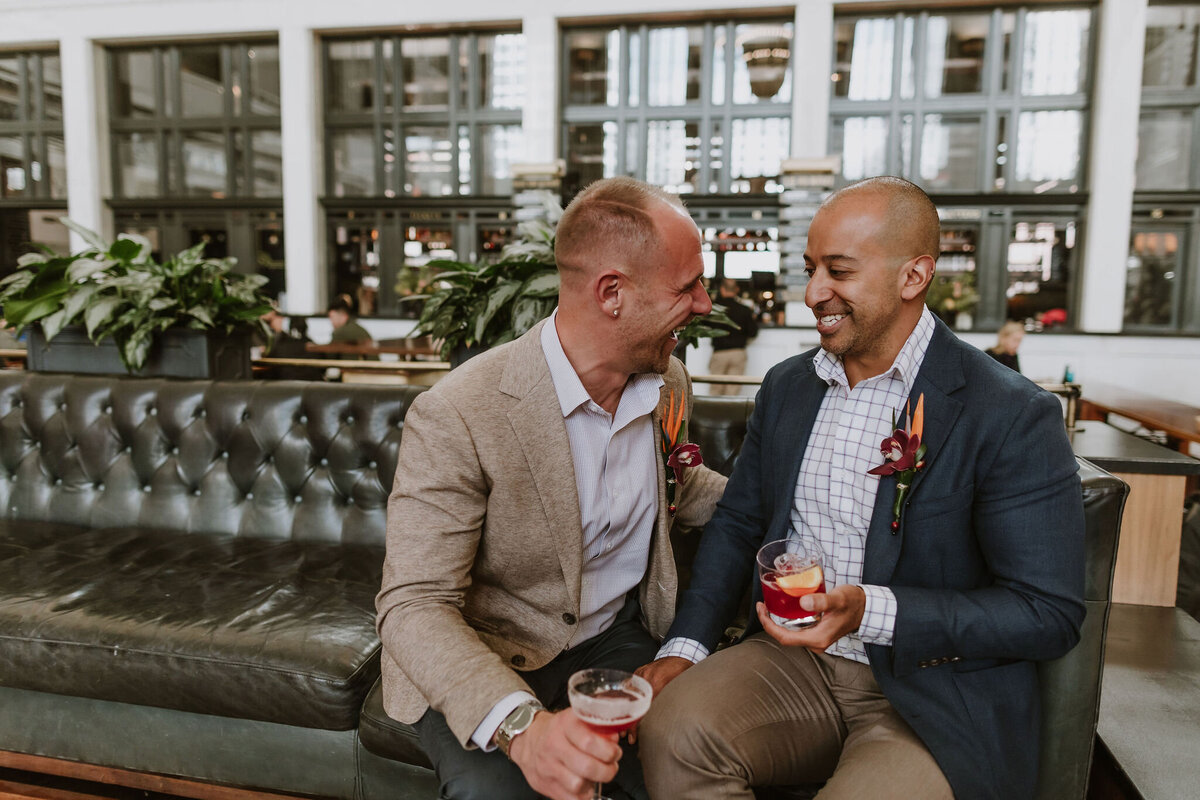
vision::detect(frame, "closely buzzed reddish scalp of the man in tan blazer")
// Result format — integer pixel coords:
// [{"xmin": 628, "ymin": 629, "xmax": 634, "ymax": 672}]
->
[{"xmin": 554, "ymin": 178, "xmax": 686, "ymax": 284}]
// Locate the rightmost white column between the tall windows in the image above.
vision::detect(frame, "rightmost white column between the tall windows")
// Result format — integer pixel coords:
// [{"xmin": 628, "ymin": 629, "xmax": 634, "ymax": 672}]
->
[{"xmin": 1079, "ymin": 0, "xmax": 1147, "ymax": 333}]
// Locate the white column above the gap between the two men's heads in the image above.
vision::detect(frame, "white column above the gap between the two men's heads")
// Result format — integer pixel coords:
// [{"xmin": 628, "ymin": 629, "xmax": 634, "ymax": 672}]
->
[{"xmin": 792, "ymin": 0, "xmax": 833, "ymax": 158}]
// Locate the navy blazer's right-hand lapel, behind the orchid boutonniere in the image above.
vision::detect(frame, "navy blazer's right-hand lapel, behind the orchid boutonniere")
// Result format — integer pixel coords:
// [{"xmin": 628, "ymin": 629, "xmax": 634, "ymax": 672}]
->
[{"xmin": 863, "ymin": 320, "xmax": 966, "ymax": 584}]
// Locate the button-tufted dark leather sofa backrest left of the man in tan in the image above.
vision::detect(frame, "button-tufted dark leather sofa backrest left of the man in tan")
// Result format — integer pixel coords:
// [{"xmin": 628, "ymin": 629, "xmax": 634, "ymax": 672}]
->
[{"xmin": 0, "ymin": 372, "xmax": 422, "ymax": 545}]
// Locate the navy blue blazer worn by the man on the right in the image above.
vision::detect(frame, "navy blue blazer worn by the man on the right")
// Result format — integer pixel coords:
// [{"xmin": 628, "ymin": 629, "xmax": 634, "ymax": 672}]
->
[{"xmin": 667, "ymin": 321, "xmax": 1084, "ymax": 800}]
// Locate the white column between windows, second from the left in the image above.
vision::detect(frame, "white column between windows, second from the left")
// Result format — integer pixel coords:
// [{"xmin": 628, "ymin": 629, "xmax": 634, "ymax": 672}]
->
[{"xmin": 280, "ymin": 28, "xmax": 329, "ymax": 314}]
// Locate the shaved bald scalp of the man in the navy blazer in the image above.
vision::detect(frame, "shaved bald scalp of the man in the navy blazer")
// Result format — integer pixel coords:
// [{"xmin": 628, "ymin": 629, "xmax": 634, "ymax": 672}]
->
[{"xmin": 822, "ymin": 176, "xmax": 942, "ymax": 261}]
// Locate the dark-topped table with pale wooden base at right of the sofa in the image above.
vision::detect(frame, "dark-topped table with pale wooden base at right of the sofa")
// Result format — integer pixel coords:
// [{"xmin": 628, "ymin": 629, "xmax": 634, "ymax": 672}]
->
[{"xmin": 1070, "ymin": 420, "xmax": 1200, "ymax": 607}]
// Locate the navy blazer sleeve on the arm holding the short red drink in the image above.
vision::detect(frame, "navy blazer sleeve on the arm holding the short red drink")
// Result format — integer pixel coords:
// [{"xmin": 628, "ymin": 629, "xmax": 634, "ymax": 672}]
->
[{"xmin": 892, "ymin": 392, "xmax": 1085, "ymax": 675}]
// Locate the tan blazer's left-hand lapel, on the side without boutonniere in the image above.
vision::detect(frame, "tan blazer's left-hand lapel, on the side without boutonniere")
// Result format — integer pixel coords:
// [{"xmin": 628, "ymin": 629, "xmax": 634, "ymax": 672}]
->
[{"xmin": 500, "ymin": 323, "xmax": 583, "ymax": 608}]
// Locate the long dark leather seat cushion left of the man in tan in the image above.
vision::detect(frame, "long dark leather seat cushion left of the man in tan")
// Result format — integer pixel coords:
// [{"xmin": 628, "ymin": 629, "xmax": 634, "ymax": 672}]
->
[{"xmin": 0, "ymin": 521, "xmax": 383, "ymax": 730}]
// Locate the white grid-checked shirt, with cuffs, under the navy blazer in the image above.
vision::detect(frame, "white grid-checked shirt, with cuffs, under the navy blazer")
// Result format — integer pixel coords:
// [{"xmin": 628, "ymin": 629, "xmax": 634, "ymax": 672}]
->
[{"xmin": 658, "ymin": 308, "xmax": 934, "ymax": 663}]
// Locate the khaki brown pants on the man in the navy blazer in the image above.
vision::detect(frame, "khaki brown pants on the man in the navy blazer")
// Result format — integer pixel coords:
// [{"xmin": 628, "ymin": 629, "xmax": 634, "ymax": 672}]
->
[{"xmin": 638, "ymin": 633, "xmax": 954, "ymax": 800}]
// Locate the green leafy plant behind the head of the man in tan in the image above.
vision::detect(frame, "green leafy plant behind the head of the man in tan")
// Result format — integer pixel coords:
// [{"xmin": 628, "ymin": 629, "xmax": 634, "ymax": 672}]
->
[{"xmin": 406, "ymin": 200, "xmax": 737, "ymax": 366}]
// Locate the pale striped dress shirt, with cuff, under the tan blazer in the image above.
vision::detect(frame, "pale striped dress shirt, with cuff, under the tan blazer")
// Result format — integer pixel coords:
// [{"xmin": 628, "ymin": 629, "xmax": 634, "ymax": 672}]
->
[{"xmin": 472, "ymin": 309, "xmax": 664, "ymax": 750}]
